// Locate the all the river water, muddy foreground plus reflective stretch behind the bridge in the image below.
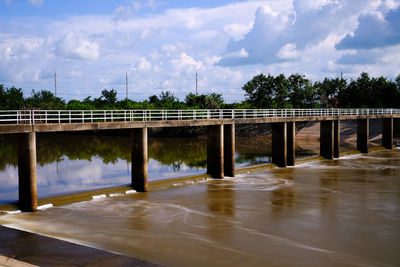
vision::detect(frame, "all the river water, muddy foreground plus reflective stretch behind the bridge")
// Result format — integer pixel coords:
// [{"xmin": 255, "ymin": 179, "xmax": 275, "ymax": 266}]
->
[{"xmin": 0, "ymin": 125, "xmax": 400, "ymax": 266}]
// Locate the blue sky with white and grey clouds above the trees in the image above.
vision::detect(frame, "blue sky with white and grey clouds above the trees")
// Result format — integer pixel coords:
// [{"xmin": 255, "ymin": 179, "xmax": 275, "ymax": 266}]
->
[{"xmin": 0, "ymin": 0, "xmax": 400, "ymax": 102}]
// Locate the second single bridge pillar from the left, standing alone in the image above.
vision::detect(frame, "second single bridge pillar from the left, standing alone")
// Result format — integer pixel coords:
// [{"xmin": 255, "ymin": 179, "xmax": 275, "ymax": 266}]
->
[{"xmin": 131, "ymin": 128, "xmax": 149, "ymax": 192}]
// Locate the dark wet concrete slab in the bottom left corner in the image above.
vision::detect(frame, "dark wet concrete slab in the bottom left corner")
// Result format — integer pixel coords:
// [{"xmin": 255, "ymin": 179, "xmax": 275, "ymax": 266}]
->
[{"xmin": 0, "ymin": 226, "xmax": 161, "ymax": 266}]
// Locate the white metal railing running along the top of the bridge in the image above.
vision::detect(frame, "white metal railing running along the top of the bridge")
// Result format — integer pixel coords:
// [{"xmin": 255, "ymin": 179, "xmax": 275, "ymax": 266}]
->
[{"xmin": 0, "ymin": 109, "xmax": 400, "ymax": 124}]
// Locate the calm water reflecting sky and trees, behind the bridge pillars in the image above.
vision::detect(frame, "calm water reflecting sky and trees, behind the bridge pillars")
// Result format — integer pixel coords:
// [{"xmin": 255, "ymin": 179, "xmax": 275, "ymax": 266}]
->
[{"xmin": 0, "ymin": 134, "xmax": 318, "ymax": 203}]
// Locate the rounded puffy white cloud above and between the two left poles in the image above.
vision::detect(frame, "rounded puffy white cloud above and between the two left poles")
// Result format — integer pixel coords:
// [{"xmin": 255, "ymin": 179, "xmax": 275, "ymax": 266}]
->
[{"xmin": 56, "ymin": 33, "xmax": 100, "ymax": 60}]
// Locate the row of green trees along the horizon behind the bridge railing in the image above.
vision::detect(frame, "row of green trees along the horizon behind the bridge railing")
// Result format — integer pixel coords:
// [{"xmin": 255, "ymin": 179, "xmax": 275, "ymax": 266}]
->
[{"xmin": 0, "ymin": 72, "xmax": 400, "ymax": 110}]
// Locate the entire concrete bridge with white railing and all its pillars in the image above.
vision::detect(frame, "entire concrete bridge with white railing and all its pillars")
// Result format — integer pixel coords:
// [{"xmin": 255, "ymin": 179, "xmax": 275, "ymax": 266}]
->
[{"xmin": 0, "ymin": 109, "xmax": 400, "ymax": 211}]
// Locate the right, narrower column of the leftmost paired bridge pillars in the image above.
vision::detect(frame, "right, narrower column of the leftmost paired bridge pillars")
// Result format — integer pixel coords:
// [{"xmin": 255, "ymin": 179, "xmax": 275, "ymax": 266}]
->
[{"xmin": 224, "ymin": 124, "xmax": 235, "ymax": 177}]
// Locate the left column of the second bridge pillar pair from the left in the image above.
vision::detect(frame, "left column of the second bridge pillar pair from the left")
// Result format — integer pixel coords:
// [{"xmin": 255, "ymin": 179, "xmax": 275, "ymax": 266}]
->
[{"xmin": 272, "ymin": 122, "xmax": 287, "ymax": 168}]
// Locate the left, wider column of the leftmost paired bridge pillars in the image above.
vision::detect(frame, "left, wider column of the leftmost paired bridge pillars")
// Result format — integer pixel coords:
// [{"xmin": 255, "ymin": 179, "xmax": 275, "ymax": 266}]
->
[{"xmin": 207, "ymin": 124, "xmax": 224, "ymax": 178}]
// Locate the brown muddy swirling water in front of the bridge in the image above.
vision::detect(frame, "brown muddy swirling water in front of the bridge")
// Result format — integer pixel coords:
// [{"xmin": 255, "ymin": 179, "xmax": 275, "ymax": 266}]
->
[{"xmin": 0, "ymin": 149, "xmax": 400, "ymax": 266}]
